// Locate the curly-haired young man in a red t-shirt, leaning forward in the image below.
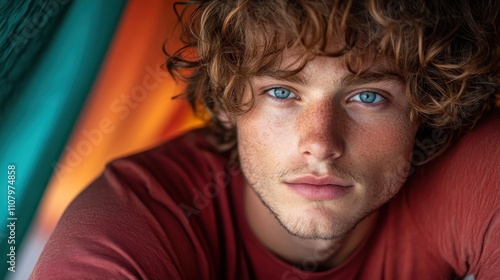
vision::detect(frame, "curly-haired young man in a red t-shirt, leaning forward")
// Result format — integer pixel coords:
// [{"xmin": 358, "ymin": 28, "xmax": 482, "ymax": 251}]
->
[{"xmin": 32, "ymin": 0, "xmax": 500, "ymax": 279}]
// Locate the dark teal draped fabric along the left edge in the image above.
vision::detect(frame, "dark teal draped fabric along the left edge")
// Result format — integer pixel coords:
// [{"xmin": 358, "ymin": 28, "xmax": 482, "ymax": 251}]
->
[{"xmin": 0, "ymin": 0, "xmax": 125, "ymax": 278}]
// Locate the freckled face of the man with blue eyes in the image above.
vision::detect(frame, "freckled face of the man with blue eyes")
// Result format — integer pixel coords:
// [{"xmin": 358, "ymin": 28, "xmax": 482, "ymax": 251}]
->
[{"xmin": 236, "ymin": 54, "xmax": 417, "ymax": 239}]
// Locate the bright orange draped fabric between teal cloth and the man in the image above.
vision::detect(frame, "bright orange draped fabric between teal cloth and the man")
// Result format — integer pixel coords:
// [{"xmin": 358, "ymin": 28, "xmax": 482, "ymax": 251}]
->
[{"xmin": 39, "ymin": 0, "xmax": 201, "ymax": 233}]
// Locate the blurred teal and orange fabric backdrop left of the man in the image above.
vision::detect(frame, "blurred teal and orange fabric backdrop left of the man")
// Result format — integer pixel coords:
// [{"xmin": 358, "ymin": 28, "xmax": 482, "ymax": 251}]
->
[{"xmin": 0, "ymin": 0, "xmax": 202, "ymax": 279}]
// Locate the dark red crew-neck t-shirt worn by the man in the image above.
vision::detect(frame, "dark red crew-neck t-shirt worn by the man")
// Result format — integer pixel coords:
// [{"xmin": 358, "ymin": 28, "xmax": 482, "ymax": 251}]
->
[{"xmin": 32, "ymin": 111, "xmax": 500, "ymax": 280}]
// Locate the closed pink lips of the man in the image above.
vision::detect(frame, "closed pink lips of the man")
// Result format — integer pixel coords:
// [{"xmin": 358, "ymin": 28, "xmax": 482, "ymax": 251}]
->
[{"xmin": 285, "ymin": 175, "xmax": 352, "ymax": 200}]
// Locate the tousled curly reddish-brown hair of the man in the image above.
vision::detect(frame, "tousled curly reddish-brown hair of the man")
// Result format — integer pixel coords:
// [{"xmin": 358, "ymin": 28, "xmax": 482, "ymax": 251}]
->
[{"xmin": 165, "ymin": 0, "xmax": 500, "ymax": 163}]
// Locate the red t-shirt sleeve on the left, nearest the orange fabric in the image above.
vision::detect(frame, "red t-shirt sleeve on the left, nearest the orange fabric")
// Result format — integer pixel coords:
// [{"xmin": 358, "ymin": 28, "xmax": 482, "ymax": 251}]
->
[{"xmin": 31, "ymin": 161, "xmax": 201, "ymax": 279}]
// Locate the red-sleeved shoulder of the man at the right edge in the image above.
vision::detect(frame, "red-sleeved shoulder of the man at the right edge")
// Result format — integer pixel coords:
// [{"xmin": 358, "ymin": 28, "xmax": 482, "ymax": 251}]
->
[{"xmin": 405, "ymin": 111, "xmax": 500, "ymax": 278}]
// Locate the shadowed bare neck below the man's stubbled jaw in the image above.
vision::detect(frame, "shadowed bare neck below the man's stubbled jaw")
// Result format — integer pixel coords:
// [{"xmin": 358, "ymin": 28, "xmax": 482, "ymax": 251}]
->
[{"xmin": 244, "ymin": 185, "xmax": 377, "ymax": 271}]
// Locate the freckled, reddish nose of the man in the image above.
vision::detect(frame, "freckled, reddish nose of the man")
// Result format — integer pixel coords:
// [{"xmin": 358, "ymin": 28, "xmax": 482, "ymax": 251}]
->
[{"xmin": 297, "ymin": 100, "xmax": 345, "ymax": 161}]
